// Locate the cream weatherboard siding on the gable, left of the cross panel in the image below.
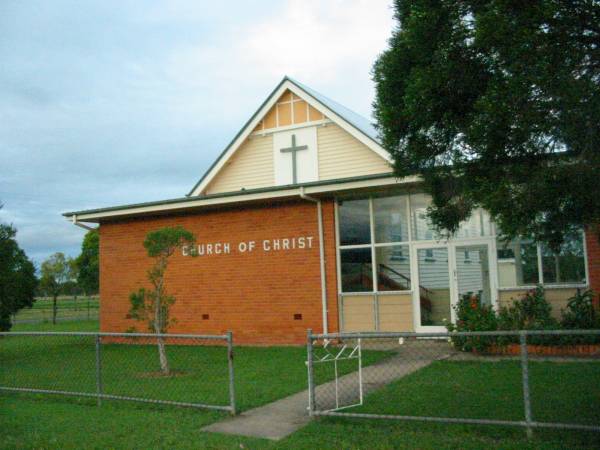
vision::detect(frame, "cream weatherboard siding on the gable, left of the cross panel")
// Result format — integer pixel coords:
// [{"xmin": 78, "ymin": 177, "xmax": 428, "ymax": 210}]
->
[{"xmin": 205, "ymin": 135, "xmax": 275, "ymax": 194}]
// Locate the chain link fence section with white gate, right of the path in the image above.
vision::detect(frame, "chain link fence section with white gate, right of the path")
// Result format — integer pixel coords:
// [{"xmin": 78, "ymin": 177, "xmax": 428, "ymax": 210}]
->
[{"xmin": 307, "ymin": 330, "xmax": 600, "ymax": 434}]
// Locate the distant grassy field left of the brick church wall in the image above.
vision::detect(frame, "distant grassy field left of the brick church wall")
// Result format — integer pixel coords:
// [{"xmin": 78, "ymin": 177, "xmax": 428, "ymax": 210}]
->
[{"xmin": 13, "ymin": 295, "xmax": 100, "ymax": 324}]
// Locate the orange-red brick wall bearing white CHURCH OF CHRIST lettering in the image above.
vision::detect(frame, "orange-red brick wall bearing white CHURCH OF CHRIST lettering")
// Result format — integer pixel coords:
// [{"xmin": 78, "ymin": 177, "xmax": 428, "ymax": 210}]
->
[{"xmin": 100, "ymin": 201, "xmax": 338, "ymax": 344}]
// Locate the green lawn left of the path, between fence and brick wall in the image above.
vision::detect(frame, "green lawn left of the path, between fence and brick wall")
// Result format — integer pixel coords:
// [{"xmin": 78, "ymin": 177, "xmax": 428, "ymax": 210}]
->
[{"xmin": 0, "ymin": 322, "xmax": 389, "ymax": 410}]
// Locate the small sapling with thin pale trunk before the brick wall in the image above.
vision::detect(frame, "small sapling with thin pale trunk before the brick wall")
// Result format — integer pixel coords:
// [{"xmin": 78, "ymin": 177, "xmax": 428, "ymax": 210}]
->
[{"xmin": 127, "ymin": 226, "xmax": 195, "ymax": 375}]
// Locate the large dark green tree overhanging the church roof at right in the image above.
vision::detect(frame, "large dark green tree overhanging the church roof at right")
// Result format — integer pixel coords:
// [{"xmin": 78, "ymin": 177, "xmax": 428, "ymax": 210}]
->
[{"xmin": 373, "ymin": 0, "xmax": 600, "ymax": 246}]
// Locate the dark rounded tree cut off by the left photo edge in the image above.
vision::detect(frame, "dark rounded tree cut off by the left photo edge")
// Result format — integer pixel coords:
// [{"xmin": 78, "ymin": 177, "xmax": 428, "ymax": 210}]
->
[{"xmin": 0, "ymin": 218, "xmax": 37, "ymax": 331}]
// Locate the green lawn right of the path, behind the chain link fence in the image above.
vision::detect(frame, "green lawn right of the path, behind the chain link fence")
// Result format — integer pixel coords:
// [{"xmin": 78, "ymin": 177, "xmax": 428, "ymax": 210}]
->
[{"xmin": 352, "ymin": 361, "xmax": 600, "ymax": 425}]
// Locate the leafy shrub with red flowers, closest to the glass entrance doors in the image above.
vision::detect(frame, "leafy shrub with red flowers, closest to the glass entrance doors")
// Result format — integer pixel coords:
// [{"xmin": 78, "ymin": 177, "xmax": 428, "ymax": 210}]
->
[{"xmin": 446, "ymin": 292, "xmax": 498, "ymax": 352}]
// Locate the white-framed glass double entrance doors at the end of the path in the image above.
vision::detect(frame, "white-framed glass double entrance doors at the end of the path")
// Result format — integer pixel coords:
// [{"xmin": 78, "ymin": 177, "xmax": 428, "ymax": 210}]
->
[{"xmin": 413, "ymin": 241, "xmax": 494, "ymax": 331}]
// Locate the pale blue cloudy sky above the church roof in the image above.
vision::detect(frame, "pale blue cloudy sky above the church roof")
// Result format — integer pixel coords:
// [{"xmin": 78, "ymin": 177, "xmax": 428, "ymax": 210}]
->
[{"xmin": 0, "ymin": 0, "xmax": 393, "ymax": 266}]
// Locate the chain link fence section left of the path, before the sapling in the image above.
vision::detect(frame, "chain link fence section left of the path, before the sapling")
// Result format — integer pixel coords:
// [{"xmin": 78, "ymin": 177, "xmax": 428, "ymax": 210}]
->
[{"xmin": 0, "ymin": 332, "xmax": 236, "ymax": 414}]
